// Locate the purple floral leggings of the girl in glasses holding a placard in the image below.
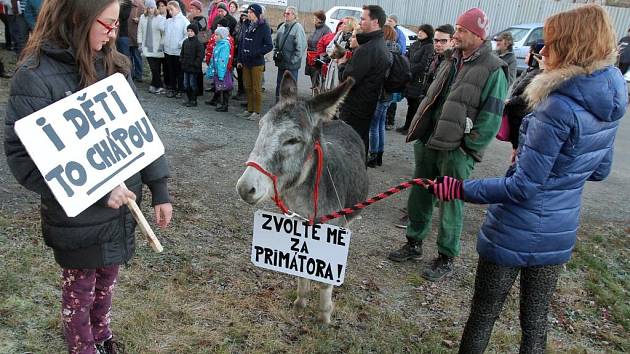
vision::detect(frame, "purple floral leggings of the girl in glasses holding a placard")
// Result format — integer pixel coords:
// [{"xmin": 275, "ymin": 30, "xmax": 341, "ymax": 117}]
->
[{"xmin": 61, "ymin": 265, "xmax": 118, "ymax": 354}]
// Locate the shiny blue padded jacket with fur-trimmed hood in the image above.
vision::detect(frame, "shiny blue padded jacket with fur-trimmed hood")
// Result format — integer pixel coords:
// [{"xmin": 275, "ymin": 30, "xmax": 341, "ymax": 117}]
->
[{"xmin": 464, "ymin": 60, "xmax": 628, "ymax": 267}]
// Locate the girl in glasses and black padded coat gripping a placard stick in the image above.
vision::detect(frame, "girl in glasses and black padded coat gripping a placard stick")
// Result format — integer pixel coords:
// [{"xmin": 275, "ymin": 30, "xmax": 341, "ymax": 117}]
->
[{"xmin": 5, "ymin": 0, "xmax": 172, "ymax": 353}]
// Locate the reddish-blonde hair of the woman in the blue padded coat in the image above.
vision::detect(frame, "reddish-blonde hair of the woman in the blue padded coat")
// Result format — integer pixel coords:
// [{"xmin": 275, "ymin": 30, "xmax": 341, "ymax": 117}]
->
[{"xmin": 544, "ymin": 4, "xmax": 617, "ymax": 70}]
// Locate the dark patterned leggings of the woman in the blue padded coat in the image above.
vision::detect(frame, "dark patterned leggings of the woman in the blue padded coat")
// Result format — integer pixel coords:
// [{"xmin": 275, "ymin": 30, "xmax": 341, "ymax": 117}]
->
[{"xmin": 459, "ymin": 257, "xmax": 562, "ymax": 354}]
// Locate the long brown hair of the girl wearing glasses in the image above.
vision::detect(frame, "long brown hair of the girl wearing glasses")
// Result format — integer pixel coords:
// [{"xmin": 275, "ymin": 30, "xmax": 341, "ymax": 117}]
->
[{"xmin": 20, "ymin": 0, "xmax": 130, "ymax": 88}]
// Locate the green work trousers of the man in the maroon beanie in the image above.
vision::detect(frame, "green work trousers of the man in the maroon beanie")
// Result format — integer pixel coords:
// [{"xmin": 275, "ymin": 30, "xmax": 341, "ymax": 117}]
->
[{"xmin": 407, "ymin": 140, "xmax": 475, "ymax": 257}]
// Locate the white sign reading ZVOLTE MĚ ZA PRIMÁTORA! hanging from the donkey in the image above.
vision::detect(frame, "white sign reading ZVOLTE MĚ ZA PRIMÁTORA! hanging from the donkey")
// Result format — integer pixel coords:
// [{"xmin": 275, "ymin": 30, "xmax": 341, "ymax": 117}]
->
[{"xmin": 251, "ymin": 210, "xmax": 351, "ymax": 286}]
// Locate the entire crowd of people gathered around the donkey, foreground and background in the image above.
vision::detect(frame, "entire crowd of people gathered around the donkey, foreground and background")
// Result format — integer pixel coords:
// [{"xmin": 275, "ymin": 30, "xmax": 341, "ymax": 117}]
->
[{"xmin": 0, "ymin": 0, "xmax": 630, "ymax": 353}]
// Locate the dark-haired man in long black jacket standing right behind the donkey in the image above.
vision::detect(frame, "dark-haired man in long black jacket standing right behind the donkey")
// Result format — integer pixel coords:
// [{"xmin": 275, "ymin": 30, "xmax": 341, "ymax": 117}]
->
[{"xmin": 339, "ymin": 5, "xmax": 391, "ymax": 157}]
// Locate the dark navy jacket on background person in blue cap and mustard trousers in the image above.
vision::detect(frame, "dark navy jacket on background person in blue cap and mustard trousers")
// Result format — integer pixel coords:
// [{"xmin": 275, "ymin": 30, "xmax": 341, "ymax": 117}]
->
[{"xmin": 237, "ymin": 20, "xmax": 273, "ymax": 68}]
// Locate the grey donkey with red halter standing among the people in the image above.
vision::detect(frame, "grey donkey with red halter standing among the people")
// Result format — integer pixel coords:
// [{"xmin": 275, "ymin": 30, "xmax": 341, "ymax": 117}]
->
[{"xmin": 236, "ymin": 72, "xmax": 368, "ymax": 324}]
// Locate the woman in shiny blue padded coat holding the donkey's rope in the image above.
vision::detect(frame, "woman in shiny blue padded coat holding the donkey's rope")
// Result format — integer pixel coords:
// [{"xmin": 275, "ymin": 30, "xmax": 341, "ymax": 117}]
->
[{"xmin": 429, "ymin": 5, "xmax": 628, "ymax": 353}]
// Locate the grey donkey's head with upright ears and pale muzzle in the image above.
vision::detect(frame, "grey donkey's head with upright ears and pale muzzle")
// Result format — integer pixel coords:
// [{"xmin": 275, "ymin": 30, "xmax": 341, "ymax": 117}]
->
[{"xmin": 236, "ymin": 72, "xmax": 354, "ymax": 204}]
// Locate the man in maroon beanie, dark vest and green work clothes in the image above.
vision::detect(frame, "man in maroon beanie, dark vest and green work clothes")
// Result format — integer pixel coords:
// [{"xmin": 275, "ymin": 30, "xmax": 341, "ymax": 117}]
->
[{"xmin": 389, "ymin": 8, "xmax": 507, "ymax": 281}]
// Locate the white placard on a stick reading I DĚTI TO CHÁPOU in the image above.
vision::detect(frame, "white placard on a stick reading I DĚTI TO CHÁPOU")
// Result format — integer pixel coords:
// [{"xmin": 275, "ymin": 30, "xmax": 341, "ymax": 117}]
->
[{"xmin": 15, "ymin": 73, "xmax": 164, "ymax": 252}]
